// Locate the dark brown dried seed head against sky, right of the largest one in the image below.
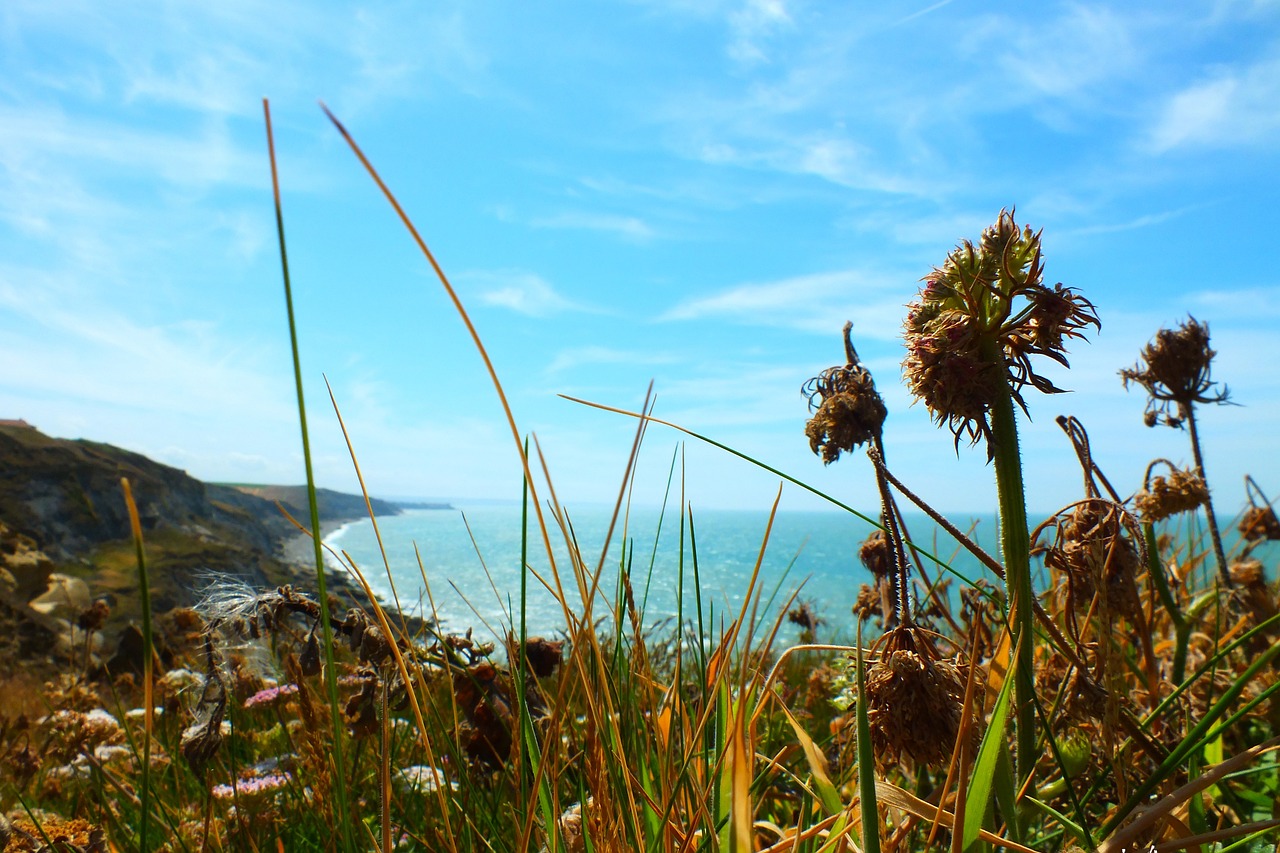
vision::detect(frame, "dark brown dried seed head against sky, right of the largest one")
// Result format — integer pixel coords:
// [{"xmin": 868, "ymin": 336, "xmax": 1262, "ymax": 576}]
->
[{"xmin": 1120, "ymin": 316, "xmax": 1228, "ymax": 427}]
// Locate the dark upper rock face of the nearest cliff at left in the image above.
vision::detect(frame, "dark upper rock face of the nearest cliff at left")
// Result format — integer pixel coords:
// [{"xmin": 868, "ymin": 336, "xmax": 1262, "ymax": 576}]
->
[{"xmin": 0, "ymin": 427, "xmax": 293, "ymax": 561}]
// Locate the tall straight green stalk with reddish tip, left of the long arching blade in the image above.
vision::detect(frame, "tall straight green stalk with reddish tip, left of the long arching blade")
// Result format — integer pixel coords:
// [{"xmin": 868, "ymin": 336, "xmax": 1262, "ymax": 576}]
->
[{"xmin": 262, "ymin": 99, "xmax": 357, "ymax": 850}]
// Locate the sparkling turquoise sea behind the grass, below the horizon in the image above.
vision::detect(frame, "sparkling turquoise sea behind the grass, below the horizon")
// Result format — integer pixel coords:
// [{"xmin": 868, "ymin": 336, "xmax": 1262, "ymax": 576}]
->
[{"xmin": 325, "ymin": 503, "xmax": 997, "ymax": 642}]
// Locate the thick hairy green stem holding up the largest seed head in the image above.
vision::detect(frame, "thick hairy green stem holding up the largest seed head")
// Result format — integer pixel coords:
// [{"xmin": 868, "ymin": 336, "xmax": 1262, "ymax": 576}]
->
[{"xmin": 989, "ymin": 345, "xmax": 1036, "ymax": 788}]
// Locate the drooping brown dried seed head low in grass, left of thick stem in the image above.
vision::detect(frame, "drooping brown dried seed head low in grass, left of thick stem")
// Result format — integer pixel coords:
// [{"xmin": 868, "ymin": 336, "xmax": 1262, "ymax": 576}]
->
[{"xmin": 867, "ymin": 626, "xmax": 979, "ymax": 767}]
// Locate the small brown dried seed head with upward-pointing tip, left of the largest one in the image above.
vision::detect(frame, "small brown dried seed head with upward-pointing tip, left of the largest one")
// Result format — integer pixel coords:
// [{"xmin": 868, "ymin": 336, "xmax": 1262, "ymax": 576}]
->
[{"xmin": 801, "ymin": 323, "xmax": 888, "ymax": 465}]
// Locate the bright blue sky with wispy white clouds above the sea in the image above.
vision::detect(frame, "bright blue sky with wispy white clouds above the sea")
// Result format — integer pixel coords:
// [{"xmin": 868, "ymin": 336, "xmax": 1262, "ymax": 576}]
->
[{"xmin": 0, "ymin": 0, "xmax": 1280, "ymax": 514}]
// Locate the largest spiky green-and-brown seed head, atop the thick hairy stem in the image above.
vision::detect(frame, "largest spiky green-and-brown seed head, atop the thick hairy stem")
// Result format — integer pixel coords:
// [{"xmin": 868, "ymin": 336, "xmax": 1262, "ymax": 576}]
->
[{"xmin": 902, "ymin": 210, "xmax": 1101, "ymax": 443}]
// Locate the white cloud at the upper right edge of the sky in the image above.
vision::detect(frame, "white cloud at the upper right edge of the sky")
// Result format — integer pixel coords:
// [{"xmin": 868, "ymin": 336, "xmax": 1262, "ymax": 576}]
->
[{"xmin": 1147, "ymin": 58, "xmax": 1280, "ymax": 154}]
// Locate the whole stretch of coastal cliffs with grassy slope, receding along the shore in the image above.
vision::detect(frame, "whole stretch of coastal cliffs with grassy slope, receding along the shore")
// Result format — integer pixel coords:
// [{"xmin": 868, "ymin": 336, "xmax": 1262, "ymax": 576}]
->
[{"xmin": 0, "ymin": 423, "xmax": 430, "ymax": 666}]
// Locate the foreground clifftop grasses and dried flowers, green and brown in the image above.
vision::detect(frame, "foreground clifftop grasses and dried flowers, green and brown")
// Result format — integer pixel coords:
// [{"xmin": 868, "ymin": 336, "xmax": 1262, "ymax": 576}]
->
[{"xmin": 0, "ymin": 109, "xmax": 1280, "ymax": 853}]
